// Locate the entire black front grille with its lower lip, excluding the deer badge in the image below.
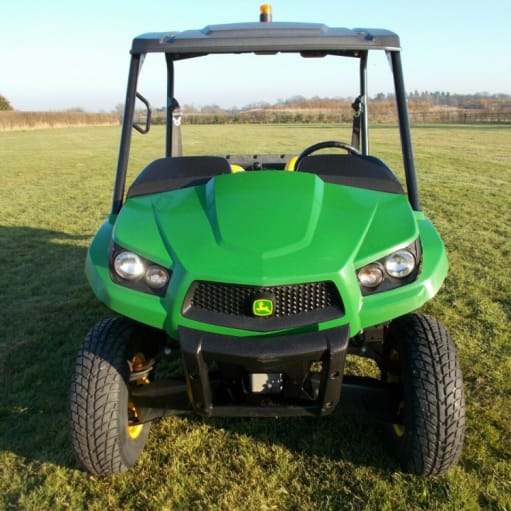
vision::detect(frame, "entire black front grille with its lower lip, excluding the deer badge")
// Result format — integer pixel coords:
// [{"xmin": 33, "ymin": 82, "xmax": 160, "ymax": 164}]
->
[{"xmin": 183, "ymin": 281, "xmax": 344, "ymax": 331}]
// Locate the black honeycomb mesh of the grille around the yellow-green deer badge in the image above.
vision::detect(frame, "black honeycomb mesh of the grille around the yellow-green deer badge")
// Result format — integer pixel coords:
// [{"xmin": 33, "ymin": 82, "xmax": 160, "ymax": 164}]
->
[{"xmin": 184, "ymin": 281, "xmax": 342, "ymax": 319}]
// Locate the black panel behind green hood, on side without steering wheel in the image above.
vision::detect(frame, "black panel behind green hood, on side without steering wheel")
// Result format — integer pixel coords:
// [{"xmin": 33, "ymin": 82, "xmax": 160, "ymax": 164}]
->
[{"xmin": 127, "ymin": 156, "xmax": 231, "ymax": 198}]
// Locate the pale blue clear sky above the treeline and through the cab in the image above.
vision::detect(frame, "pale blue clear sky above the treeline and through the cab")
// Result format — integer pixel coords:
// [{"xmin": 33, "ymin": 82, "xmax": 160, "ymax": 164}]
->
[{"xmin": 0, "ymin": 0, "xmax": 511, "ymax": 112}]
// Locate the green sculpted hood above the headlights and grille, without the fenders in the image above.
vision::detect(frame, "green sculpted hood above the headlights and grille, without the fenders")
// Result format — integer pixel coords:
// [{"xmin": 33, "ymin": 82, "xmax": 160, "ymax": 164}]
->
[{"xmin": 114, "ymin": 171, "xmax": 418, "ymax": 285}]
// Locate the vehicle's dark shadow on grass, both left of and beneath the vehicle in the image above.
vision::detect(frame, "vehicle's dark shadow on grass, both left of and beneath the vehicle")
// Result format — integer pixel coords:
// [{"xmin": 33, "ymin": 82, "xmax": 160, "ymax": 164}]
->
[{"xmin": 0, "ymin": 227, "xmax": 396, "ymax": 476}]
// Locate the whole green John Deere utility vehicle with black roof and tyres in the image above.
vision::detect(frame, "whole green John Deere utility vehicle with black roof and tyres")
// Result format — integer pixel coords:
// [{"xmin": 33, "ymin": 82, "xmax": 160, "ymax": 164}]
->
[{"xmin": 70, "ymin": 8, "xmax": 465, "ymax": 475}]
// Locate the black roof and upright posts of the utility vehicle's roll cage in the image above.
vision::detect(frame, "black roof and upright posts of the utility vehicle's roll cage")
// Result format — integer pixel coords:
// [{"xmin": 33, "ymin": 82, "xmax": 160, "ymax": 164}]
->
[{"xmin": 112, "ymin": 22, "xmax": 421, "ymax": 215}]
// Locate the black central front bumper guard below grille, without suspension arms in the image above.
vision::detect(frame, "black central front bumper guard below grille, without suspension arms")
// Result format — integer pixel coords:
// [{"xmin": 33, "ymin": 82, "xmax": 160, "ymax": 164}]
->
[{"xmin": 179, "ymin": 325, "xmax": 349, "ymax": 417}]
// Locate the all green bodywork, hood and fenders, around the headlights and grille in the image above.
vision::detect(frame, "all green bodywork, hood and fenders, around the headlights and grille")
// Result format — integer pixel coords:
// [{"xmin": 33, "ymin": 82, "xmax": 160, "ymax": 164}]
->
[{"xmin": 86, "ymin": 171, "xmax": 447, "ymax": 338}]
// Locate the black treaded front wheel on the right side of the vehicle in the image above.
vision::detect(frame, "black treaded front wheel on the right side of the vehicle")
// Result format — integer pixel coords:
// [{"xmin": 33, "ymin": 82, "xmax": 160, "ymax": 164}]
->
[{"xmin": 384, "ymin": 314, "xmax": 465, "ymax": 476}]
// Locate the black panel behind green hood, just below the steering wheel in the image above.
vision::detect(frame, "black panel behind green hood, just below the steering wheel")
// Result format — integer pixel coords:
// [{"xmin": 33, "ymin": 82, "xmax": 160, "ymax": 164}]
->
[{"xmin": 296, "ymin": 154, "xmax": 404, "ymax": 194}]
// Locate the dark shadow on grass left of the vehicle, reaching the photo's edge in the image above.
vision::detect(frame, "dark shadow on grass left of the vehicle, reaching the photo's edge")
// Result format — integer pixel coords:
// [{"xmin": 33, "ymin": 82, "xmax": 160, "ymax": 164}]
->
[{"xmin": 0, "ymin": 226, "xmax": 104, "ymax": 466}]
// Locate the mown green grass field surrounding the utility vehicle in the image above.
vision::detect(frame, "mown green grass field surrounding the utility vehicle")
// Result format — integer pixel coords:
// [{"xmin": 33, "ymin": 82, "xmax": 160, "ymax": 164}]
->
[{"xmin": 0, "ymin": 125, "xmax": 511, "ymax": 511}]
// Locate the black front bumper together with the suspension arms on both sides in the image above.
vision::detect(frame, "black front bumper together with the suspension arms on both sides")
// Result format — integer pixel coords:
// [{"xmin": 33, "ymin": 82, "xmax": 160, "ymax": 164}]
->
[{"xmin": 130, "ymin": 325, "xmax": 398, "ymax": 424}]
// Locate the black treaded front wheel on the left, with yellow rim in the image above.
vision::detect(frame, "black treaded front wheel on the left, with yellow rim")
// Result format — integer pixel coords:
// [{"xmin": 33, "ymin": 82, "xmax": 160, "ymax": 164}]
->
[{"xmin": 70, "ymin": 318, "xmax": 155, "ymax": 475}]
